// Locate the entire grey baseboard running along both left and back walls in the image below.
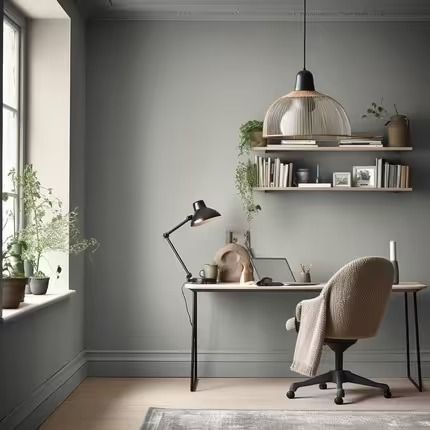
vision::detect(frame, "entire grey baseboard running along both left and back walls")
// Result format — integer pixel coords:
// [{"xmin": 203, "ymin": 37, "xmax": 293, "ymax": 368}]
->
[{"xmin": 0, "ymin": 350, "xmax": 424, "ymax": 430}]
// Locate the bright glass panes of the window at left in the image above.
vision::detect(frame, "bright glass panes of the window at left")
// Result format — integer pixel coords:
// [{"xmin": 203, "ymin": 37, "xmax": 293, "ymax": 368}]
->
[{"xmin": 2, "ymin": 14, "xmax": 23, "ymax": 249}]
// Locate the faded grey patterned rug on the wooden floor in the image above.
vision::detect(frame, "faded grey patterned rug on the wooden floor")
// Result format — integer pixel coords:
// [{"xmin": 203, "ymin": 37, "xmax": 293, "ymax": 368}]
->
[{"xmin": 142, "ymin": 408, "xmax": 430, "ymax": 430}]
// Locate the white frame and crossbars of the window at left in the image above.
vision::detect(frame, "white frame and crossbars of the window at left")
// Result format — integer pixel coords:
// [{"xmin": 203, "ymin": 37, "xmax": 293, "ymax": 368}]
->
[{"xmin": 2, "ymin": 0, "xmax": 26, "ymax": 240}]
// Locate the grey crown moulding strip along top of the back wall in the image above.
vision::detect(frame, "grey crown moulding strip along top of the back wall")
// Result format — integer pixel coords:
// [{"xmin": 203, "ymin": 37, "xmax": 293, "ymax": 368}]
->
[{"xmin": 81, "ymin": 0, "xmax": 430, "ymax": 21}]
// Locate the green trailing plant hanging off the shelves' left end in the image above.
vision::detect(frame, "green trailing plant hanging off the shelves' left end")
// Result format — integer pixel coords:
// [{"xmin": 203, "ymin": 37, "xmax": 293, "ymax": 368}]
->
[{"xmin": 235, "ymin": 120, "xmax": 263, "ymax": 222}]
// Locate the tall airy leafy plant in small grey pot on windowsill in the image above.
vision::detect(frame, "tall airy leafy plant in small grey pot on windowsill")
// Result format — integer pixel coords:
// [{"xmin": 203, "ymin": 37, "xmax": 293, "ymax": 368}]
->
[{"xmin": 10, "ymin": 164, "xmax": 98, "ymax": 295}]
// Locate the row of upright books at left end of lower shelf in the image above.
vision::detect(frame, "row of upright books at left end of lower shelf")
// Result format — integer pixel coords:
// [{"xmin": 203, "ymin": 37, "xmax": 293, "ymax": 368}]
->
[{"xmin": 255, "ymin": 157, "xmax": 293, "ymax": 188}]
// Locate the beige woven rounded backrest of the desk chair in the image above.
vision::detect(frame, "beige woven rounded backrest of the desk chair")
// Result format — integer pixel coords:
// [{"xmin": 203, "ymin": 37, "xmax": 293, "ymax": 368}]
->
[{"xmin": 323, "ymin": 257, "xmax": 394, "ymax": 339}]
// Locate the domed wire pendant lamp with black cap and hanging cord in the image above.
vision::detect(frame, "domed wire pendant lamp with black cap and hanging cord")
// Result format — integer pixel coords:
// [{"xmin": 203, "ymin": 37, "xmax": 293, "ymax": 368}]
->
[{"xmin": 263, "ymin": 0, "xmax": 351, "ymax": 139}]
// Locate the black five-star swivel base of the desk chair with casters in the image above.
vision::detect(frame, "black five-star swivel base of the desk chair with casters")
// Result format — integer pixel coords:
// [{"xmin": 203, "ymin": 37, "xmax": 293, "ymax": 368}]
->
[{"xmin": 287, "ymin": 340, "xmax": 391, "ymax": 405}]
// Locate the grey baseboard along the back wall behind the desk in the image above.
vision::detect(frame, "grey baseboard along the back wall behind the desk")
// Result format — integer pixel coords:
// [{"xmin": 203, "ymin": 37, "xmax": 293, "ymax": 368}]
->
[{"xmin": 87, "ymin": 350, "xmax": 430, "ymax": 377}]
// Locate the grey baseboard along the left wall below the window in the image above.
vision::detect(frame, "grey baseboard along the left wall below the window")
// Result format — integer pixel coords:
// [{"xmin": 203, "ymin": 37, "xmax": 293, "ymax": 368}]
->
[{"xmin": 0, "ymin": 351, "xmax": 87, "ymax": 430}]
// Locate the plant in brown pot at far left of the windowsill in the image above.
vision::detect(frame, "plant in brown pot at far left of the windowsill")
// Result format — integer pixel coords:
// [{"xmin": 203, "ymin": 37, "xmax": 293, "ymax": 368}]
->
[{"xmin": 2, "ymin": 242, "xmax": 28, "ymax": 309}]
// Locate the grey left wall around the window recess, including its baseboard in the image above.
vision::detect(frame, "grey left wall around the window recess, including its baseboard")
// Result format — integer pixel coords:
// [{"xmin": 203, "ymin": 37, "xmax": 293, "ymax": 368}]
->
[{"xmin": 0, "ymin": 0, "xmax": 86, "ymax": 429}]
